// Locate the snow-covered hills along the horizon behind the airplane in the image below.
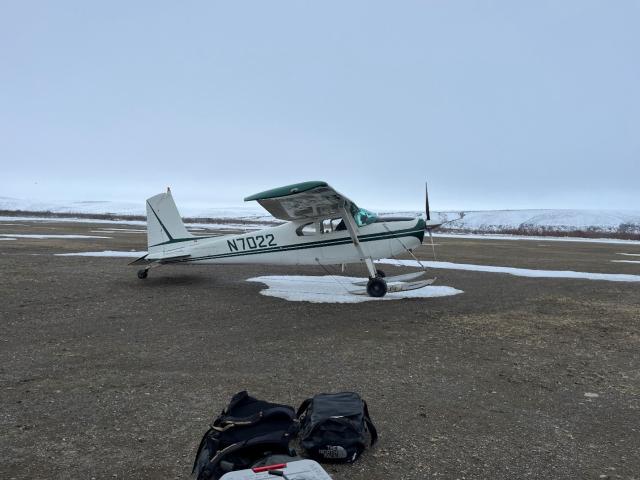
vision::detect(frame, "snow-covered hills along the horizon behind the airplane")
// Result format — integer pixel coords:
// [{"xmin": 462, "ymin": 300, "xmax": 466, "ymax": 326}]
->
[{"xmin": 0, "ymin": 197, "xmax": 640, "ymax": 235}]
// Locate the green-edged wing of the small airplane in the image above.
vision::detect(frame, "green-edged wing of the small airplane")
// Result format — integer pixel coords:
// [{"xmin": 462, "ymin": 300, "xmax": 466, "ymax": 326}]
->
[{"xmin": 244, "ymin": 182, "xmax": 353, "ymax": 221}]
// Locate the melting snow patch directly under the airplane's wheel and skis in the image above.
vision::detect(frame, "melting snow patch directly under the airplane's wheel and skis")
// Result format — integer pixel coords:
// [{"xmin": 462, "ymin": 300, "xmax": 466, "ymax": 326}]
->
[{"xmin": 247, "ymin": 275, "xmax": 464, "ymax": 303}]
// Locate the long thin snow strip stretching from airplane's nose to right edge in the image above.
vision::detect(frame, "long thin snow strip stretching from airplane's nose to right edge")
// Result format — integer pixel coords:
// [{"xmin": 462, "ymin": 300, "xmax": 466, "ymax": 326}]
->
[{"xmin": 376, "ymin": 258, "xmax": 640, "ymax": 282}]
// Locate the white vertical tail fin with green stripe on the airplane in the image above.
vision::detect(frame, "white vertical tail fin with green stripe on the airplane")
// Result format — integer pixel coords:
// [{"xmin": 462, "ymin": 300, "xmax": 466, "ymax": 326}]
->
[{"xmin": 147, "ymin": 188, "xmax": 193, "ymax": 252}]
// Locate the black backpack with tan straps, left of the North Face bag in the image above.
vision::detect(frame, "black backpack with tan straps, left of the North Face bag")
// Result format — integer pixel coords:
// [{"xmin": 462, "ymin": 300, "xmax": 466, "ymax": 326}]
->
[{"xmin": 191, "ymin": 391, "xmax": 297, "ymax": 480}]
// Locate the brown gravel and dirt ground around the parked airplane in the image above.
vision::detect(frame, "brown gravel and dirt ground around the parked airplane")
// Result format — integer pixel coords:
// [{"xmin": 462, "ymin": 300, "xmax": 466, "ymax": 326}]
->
[{"xmin": 0, "ymin": 221, "xmax": 640, "ymax": 480}]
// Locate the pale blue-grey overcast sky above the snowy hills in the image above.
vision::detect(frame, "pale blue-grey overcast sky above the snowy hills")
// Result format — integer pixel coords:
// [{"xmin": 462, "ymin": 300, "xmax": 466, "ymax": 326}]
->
[{"xmin": 0, "ymin": 0, "xmax": 640, "ymax": 209}]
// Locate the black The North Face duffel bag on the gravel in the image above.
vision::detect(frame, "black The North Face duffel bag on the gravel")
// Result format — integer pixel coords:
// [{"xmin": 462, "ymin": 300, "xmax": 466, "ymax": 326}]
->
[{"xmin": 297, "ymin": 392, "xmax": 378, "ymax": 463}]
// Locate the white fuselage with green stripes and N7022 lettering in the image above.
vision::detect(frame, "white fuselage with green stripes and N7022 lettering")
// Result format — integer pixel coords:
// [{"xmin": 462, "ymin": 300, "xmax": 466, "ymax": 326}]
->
[{"xmin": 147, "ymin": 218, "xmax": 425, "ymax": 265}]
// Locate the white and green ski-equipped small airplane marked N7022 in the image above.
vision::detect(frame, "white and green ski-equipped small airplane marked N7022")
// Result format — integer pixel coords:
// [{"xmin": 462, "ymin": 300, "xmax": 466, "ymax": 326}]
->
[{"xmin": 130, "ymin": 181, "xmax": 442, "ymax": 297}]
